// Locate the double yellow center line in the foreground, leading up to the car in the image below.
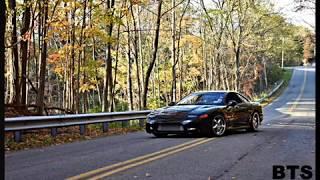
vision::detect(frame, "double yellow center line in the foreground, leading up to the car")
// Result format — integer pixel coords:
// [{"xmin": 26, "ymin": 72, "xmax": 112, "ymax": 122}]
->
[{"xmin": 68, "ymin": 138, "xmax": 215, "ymax": 180}]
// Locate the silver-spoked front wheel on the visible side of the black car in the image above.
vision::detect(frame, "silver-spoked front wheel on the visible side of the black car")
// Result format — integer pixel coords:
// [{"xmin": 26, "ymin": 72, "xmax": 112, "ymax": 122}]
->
[{"xmin": 208, "ymin": 114, "xmax": 227, "ymax": 137}]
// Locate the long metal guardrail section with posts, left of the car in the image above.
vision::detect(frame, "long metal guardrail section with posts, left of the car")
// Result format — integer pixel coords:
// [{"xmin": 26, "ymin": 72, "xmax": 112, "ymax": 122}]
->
[{"xmin": 5, "ymin": 110, "xmax": 151, "ymax": 142}]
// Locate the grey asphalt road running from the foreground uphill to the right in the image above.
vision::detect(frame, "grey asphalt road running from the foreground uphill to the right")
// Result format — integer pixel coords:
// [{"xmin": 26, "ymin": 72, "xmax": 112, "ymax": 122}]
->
[{"xmin": 5, "ymin": 67, "xmax": 316, "ymax": 180}]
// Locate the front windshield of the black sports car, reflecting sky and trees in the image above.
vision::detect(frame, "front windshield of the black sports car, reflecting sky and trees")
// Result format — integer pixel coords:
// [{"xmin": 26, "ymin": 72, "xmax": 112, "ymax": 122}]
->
[{"xmin": 177, "ymin": 93, "xmax": 225, "ymax": 105}]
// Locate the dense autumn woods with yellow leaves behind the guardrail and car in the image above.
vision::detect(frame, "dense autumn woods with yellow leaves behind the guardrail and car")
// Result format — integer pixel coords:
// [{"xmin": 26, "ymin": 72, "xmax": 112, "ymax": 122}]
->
[{"xmin": 4, "ymin": 0, "xmax": 315, "ymax": 114}]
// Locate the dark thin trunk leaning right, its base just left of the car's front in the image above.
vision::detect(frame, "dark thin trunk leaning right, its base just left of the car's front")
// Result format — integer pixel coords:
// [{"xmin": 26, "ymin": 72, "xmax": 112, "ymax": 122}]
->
[{"xmin": 142, "ymin": 0, "xmax": 162, "ymax": 109}]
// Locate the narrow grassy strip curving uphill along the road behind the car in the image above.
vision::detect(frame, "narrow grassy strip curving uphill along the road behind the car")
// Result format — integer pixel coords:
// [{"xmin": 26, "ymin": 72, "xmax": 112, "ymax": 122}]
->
[{"xmin": 261, "ymin": 69, "xmax": 293, "ymax": 107}]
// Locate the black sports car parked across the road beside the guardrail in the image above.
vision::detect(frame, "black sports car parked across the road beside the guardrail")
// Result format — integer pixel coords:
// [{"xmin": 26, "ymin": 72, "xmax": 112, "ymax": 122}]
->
[{"xmin": 146, "ymin": 91, "xmax": 263, "ymax": 137}]
